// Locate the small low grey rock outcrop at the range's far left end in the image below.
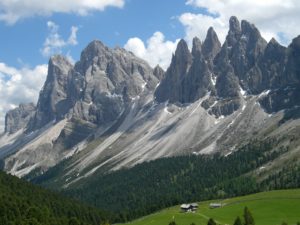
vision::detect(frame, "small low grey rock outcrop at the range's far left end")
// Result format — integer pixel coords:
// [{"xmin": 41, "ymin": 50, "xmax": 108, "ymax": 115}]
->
[{"xmin": 5, "ymin": 103, "xmax": 36, "ymax": 134}]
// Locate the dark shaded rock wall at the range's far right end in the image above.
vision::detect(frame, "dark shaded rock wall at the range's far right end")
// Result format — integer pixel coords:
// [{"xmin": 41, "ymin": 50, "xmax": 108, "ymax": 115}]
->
[{"xmin": 260, "ymin": 36, "xmax": 300, "ymax": 113}]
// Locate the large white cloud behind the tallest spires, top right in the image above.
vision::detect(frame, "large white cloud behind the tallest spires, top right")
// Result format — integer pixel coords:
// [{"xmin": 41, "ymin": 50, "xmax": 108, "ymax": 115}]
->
[{"xmin": 179, "ymin": 0, "xmax": 300, "ymax": 44}]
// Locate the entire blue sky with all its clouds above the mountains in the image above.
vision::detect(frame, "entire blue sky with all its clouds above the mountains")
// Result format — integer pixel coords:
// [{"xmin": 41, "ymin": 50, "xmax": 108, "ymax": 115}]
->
[{"xmin": 0, "ymin": 0, "xmax": 300, "ymax": 132}]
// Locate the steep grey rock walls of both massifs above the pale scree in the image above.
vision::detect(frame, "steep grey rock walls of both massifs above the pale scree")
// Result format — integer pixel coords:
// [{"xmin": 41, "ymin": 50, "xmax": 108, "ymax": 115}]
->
[{"xmin": 6, "ymin": 16, "xmax": 300, "ymax": 135}]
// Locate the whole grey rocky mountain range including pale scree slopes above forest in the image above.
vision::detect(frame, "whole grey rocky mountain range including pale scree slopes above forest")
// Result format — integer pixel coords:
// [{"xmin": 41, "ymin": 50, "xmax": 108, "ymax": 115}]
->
[{"xmin": 0, "ymin": 17, "xmax": 300, "ymax": 185}]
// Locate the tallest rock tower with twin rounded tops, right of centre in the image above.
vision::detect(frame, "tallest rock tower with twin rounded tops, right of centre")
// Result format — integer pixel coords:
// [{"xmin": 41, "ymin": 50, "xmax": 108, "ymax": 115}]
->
[{"xmin": 214, "ymin": 17, "xmax": 267, "ymax": 94}]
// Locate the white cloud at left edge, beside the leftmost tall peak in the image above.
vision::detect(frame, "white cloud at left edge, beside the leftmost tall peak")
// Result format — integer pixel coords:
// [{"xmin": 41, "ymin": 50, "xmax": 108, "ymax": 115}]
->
[{"xmin": 0, "ymin": 62, "xmax": 48, "ymax": 133}]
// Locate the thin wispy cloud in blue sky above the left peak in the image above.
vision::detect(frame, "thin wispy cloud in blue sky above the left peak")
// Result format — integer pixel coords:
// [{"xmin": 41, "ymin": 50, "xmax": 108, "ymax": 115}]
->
[{"xmin": 41, "ymin": 21, "xmax": 78, "ymax": 57}]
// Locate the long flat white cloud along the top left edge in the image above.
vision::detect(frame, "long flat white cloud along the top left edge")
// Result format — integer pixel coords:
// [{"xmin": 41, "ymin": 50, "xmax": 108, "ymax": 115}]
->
[{"xmin": 0, "ymin": 0, "xmax": 125, "ymax": 24}]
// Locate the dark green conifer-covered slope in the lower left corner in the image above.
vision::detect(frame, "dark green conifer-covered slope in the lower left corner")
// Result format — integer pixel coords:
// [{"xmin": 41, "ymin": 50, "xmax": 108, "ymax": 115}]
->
[{"xmin": 0, "ymin": 171, "xmax": 107, "ymax": 225}]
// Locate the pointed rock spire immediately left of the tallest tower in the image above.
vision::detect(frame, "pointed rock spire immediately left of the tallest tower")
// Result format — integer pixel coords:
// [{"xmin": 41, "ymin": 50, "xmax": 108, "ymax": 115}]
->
[{"xmin": 202, "ymin": 27, "xmax": 221, "ymax": 59}]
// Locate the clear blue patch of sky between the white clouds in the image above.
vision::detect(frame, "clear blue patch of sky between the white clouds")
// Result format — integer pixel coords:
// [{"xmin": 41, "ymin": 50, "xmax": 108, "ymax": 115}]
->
[{"xmin": 0, "ymin": 0, "xmax": 201, "ymax": 68}]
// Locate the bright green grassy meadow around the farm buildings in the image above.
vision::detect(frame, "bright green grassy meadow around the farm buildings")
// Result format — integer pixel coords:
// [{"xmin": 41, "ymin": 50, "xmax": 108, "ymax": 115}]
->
[{"xmin": 121, "ymin": 189, "xmax": 300, "ymax": 225}]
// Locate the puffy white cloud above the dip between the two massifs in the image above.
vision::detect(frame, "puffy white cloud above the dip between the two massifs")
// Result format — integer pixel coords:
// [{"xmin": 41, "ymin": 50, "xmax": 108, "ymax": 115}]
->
[{"xmin": 124, "ymin": 32, "xmax": 179, "ymax": 69}]
